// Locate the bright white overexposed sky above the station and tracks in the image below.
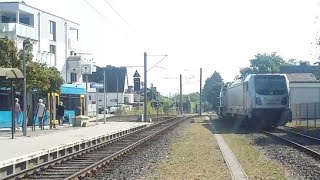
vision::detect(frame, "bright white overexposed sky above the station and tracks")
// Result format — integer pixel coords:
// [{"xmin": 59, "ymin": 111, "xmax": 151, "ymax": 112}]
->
[{"xmin": 25, "ymin": 0, "xmax": 320, "ymax": 95}]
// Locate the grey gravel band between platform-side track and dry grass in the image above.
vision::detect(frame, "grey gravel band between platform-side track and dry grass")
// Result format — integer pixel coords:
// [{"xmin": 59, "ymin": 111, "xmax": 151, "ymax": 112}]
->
[{"xmin": 87, "ymin": 118, "xmax": 195, "ymax": 180}]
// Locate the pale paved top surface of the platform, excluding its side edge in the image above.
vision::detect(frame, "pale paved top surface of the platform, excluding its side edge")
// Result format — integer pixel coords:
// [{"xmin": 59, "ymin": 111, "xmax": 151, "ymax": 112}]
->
[{"xmin": 0, "ymin": 117, "xmax": 149, "ymax": 163}]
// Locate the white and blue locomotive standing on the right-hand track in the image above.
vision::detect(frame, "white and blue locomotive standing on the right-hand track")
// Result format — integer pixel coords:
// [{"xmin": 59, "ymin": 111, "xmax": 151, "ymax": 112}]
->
[{"xmin": 218, "ymin": 74, "xmax": 292, "ymax": 128}]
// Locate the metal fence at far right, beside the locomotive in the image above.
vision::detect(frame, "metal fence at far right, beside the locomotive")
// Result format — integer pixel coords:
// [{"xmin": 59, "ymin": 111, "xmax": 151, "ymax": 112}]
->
[{"xmin": 291, "ymin": 102, "xmax": 320, "ymax": 127}]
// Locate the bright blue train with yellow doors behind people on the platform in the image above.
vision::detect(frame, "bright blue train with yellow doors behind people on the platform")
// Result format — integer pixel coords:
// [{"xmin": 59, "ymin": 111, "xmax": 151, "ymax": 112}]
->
[{"xmin": 0, "ymin": 84, "xmax": 86, "ymax": 128}]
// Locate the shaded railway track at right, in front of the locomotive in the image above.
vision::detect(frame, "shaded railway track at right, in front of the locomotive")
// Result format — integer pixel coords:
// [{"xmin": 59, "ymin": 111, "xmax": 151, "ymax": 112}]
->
[{"xmin": 263, "ymin": 128, "xmax": 320, "ymax": 160}]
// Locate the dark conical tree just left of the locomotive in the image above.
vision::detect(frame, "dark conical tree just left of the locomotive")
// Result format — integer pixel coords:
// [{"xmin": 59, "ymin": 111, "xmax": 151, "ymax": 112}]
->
[{"xmin": 202, "ymin": 71, "xmax": 224, "ymax": 109}]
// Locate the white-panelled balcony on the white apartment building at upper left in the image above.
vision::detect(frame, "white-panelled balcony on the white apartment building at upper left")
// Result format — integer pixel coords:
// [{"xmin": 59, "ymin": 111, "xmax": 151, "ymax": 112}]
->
[{"xmin": 0, "ymin": 23, "xmax": 38, "ymax": 40}]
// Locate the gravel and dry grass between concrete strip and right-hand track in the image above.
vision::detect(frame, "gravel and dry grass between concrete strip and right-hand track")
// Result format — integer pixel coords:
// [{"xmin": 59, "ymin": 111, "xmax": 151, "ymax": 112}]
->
[{"xmin": 209, "ymin": 115, "xmax": 320, "ymax": 180}]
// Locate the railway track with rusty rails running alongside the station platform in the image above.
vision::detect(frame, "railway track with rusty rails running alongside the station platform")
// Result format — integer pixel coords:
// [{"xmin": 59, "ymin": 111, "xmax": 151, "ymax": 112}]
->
[{"xmin": 4, "ymin": 117, "xmax": 190, "ymax": 180}]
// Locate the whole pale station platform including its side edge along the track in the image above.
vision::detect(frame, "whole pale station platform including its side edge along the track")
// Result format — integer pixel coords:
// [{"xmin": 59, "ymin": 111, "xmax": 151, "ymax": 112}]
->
[{"xmin": 0, "ymin": 116, "xmax": 150, "ymax": 179}]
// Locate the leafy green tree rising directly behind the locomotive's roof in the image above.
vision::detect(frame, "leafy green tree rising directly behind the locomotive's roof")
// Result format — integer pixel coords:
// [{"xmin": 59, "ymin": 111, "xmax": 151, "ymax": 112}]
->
[{"xmin": 240, "ymin": 52, "xmax": 286, "ymax": 78}]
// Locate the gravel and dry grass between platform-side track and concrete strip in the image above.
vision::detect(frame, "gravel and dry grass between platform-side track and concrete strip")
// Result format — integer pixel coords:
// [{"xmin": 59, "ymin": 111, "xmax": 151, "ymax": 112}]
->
[{"xmin": 88, "ymin": 116, "xmax": 231, "ymax": 179}]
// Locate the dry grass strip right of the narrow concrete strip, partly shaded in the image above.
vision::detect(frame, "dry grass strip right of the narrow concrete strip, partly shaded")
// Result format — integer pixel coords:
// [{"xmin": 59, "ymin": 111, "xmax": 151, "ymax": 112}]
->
[{"xmin": 211, "ymin": 116, "xmax": 287, "ymax": 180}]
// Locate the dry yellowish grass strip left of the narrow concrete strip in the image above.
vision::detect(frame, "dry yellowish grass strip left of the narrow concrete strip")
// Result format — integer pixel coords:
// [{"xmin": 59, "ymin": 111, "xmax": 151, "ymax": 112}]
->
[{"xmin": 152, "ymin": 118, "xmax": 231, "ymax": 179}]
